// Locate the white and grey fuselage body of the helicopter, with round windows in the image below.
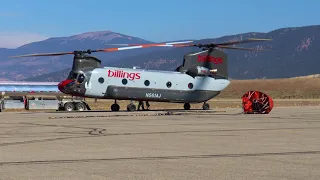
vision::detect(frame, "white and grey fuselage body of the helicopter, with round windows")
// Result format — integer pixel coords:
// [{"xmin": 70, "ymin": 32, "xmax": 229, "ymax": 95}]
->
[{"xmin": 84, "ymin": 67, "xmax": 230, "ymax": 103}]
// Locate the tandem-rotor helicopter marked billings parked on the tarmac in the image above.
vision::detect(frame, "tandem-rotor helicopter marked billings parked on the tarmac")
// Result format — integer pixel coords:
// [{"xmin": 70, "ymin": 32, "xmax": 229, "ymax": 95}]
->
[{"xmin": 12, "ymin": 38, "xmax": 271, "ymax": 111}]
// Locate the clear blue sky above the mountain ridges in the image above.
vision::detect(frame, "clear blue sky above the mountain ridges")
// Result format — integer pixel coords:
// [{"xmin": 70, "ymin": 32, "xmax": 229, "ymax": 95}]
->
[{"xmin": 0, "ymin": 0, "xmax": 320, "ymax": 48}]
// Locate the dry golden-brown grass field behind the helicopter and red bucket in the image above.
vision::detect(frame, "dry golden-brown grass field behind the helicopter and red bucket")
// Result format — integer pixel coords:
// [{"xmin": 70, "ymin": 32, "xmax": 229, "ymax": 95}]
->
[{"xmin": 87, "ymin": 77, "xmax": 320, "ymax": 110}]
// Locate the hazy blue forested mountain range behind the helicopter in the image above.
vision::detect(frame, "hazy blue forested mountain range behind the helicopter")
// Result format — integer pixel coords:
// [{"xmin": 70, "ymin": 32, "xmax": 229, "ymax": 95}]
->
[{"xmin": 0, "ymin": 25, "xmax": 320, "ymax": 81}]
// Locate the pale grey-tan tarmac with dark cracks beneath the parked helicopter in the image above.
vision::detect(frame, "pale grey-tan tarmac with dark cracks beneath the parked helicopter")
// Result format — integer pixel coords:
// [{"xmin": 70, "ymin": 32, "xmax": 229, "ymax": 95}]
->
[{"xmin": 0, "ymin": 107, "xmax": 320, "ymax": 180}]
